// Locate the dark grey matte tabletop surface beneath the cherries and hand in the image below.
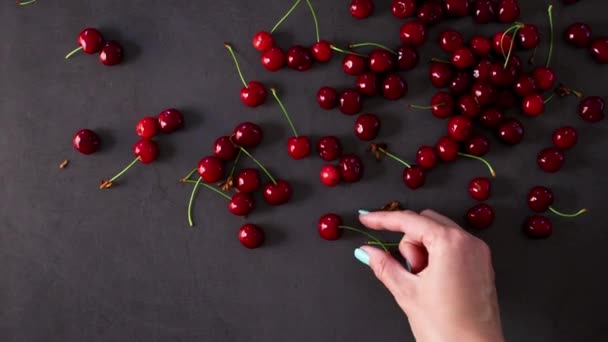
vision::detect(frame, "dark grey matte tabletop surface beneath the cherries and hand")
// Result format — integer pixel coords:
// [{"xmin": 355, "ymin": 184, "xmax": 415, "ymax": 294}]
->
[{"xmin": 0, "ymin": 0, "xmax": 608, "ymax": 341}]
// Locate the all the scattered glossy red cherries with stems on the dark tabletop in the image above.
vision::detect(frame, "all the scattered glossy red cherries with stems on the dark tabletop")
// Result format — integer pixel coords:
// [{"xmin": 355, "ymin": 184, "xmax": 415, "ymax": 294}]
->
[{"xmin": 64, "ymin": 0, "xmax": 608, "ymax": 249}]
